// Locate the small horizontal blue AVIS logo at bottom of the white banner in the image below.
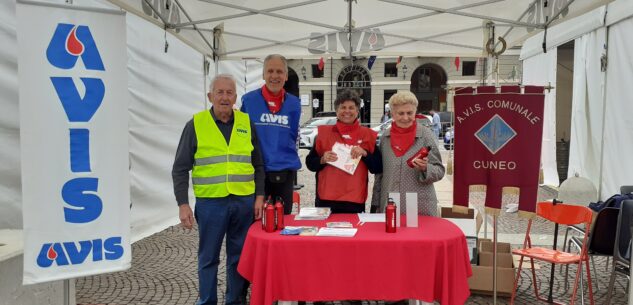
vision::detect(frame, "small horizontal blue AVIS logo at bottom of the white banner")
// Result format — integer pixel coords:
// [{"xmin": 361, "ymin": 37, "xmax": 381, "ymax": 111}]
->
[{"xmin": 37, "ymin": 236, "xmax": 124, "ymax": 268}]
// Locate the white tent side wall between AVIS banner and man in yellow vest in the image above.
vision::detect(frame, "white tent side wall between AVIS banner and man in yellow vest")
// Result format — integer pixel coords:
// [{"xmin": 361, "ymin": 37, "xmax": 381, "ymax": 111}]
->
[{"xmin": 127, "ymin": 14, "xmax": 207, "ymax": 241}]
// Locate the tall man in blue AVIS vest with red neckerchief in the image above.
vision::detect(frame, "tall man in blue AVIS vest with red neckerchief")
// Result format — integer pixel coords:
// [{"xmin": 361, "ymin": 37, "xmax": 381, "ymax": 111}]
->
[{"xmin": 241, "ymin": 54, "xmax": 301, "ymax": 214}]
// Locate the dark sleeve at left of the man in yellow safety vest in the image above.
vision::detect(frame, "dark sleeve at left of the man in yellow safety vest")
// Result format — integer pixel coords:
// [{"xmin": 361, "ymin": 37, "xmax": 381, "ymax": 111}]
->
[{"xmin": 171, "ymin": 119, "xmax": 198, "ymax": 205}]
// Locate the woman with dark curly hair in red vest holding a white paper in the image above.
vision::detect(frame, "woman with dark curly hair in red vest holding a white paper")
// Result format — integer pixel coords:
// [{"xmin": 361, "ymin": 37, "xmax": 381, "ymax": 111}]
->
[{"xmin": 306, "ymin": 90, "xmax": 382, "ymax": 213}]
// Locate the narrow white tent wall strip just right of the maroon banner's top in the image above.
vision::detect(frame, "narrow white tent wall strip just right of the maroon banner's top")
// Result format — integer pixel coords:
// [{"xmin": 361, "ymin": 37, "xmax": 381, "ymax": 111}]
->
[{"xmin": 523, "ymin": 50, "xmax": 558, "ymax": 186}]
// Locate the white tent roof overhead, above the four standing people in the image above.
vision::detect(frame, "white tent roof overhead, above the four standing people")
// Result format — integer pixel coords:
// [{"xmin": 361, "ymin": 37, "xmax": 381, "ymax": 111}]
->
[{"xmin": 110, "ymin": 0, "xmax": 610, "ymax": 59}]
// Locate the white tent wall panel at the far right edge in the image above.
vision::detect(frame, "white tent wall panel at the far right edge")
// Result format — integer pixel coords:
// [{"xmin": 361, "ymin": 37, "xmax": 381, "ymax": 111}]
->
[{"xmin": 600, "ymin": 16, "xmax": 633, "ymax": 198}]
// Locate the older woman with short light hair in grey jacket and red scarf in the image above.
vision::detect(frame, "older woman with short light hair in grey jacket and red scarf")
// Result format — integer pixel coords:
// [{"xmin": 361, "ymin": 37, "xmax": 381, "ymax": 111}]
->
[{"xmin": 372, "ymin": 91, "xmax": 444, "ymax": 216}]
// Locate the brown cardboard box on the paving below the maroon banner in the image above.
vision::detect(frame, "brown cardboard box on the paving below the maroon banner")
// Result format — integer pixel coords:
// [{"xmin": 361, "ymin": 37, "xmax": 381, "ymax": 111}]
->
[{"xmin": 468, "ymin": 239, "xmax": 515, "ymax": 296}]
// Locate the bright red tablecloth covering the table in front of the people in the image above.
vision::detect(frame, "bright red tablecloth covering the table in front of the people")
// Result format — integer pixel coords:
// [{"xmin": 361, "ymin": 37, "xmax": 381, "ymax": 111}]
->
[{"xmin": 237, "ymin": 214, "xmax": 472, "ymax": 305}]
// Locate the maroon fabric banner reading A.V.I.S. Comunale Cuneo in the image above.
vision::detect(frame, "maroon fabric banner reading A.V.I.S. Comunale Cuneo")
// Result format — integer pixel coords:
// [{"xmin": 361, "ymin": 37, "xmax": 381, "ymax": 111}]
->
[{"xmin": 453, "ymin": 86, "xmax": 545, "ymax": 212}]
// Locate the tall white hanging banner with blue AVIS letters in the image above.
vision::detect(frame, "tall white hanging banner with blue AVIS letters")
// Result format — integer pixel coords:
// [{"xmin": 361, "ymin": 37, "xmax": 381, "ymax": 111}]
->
[{"xmin": 16, "ymin": 1, "xmax": 131, "ymax": 284}]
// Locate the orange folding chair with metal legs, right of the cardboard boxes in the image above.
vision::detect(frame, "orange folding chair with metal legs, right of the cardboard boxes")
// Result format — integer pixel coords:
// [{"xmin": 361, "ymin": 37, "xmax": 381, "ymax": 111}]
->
[{"xmin": 510, "ymin": 202, "xmax": 593, "ymax": 305}]
